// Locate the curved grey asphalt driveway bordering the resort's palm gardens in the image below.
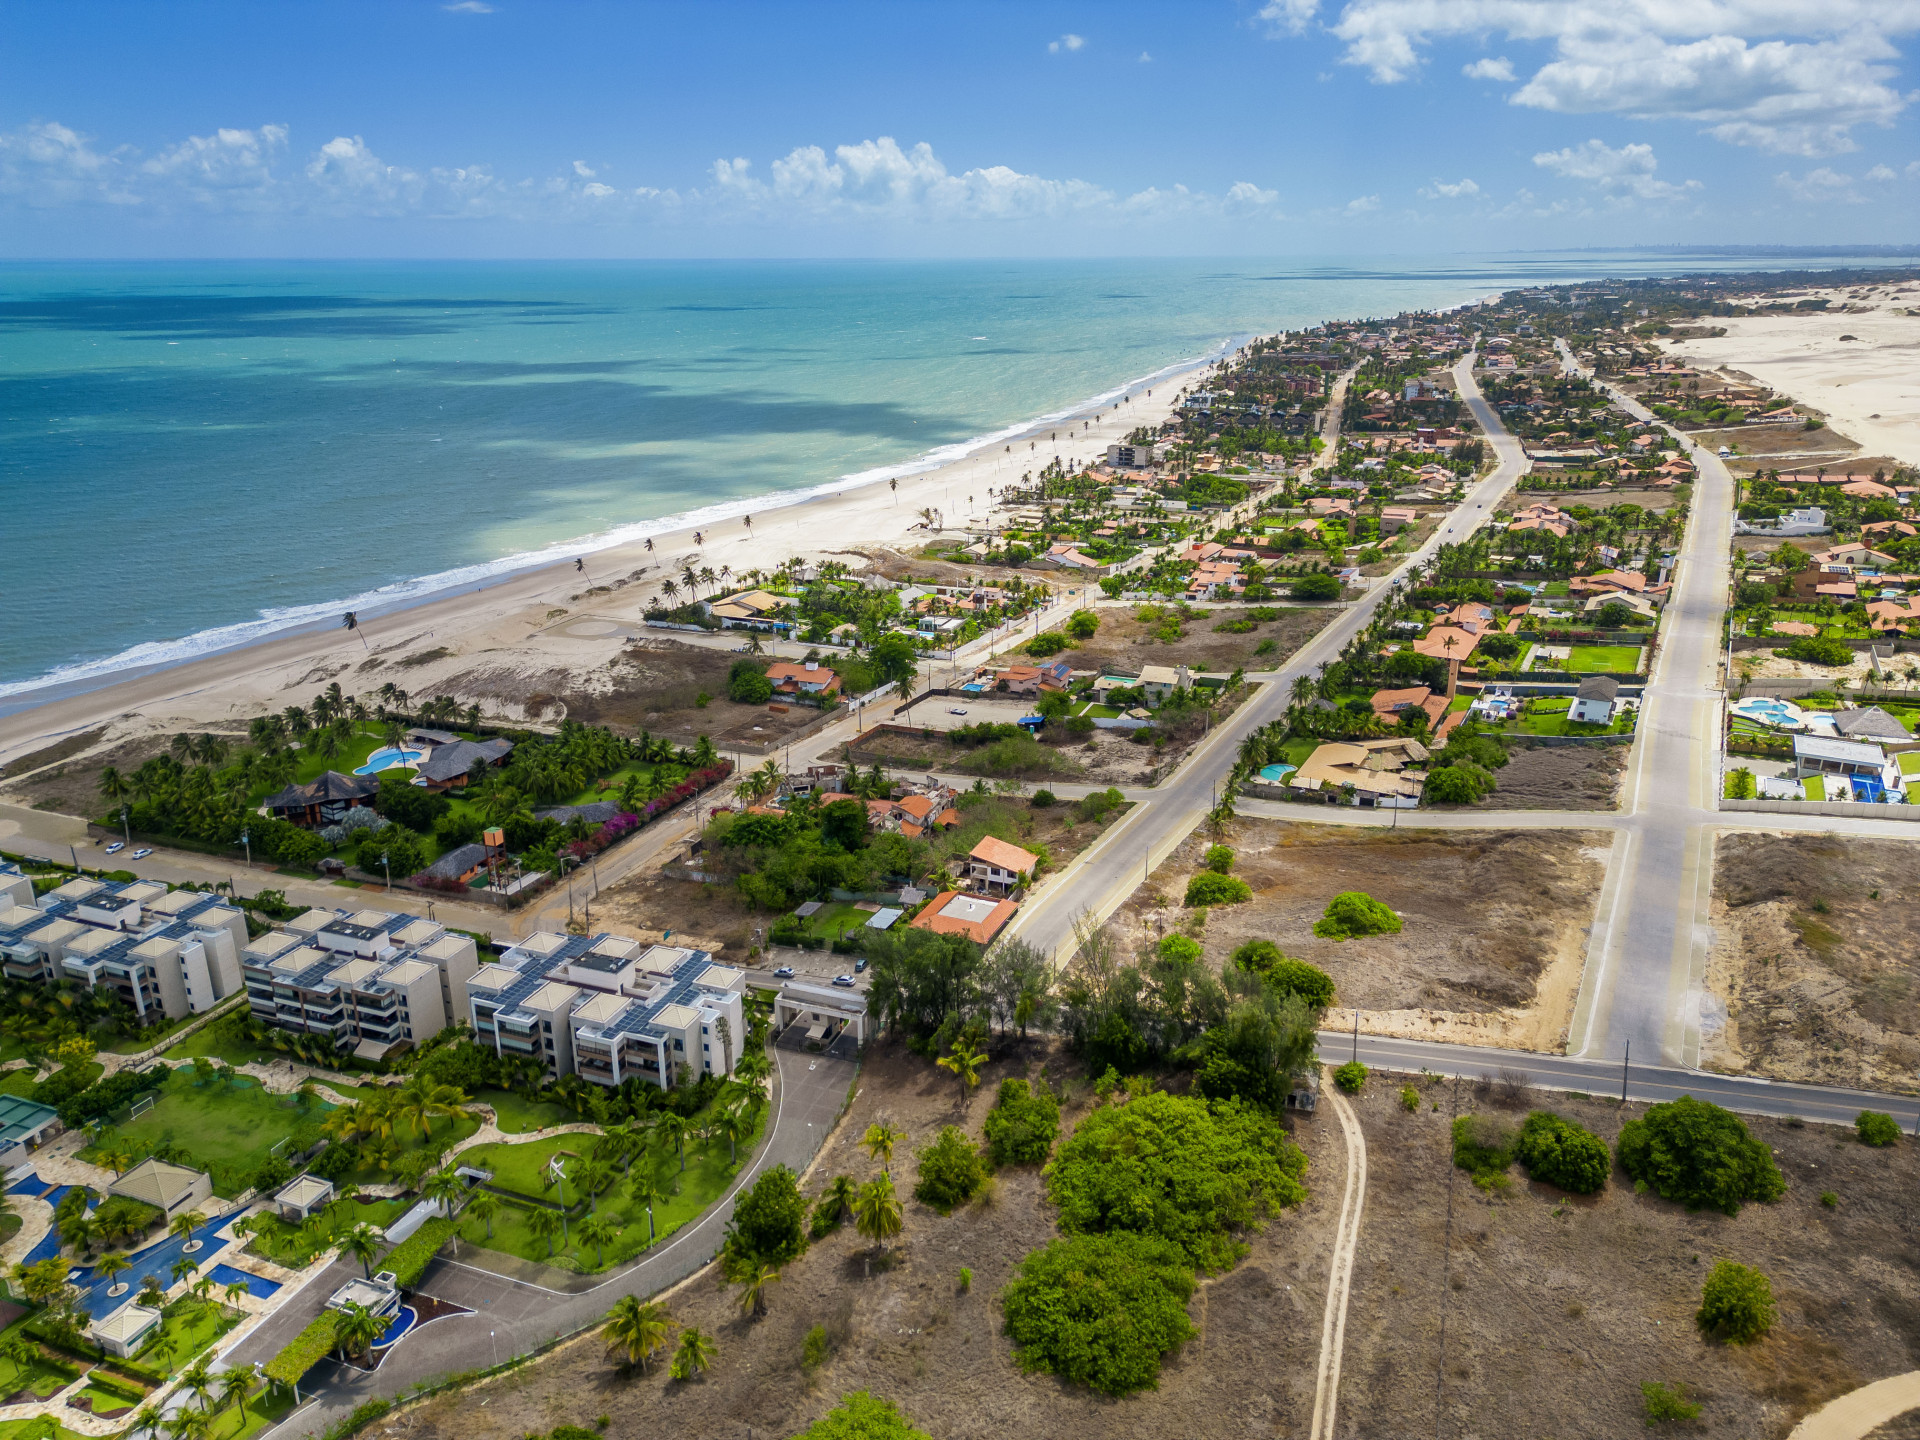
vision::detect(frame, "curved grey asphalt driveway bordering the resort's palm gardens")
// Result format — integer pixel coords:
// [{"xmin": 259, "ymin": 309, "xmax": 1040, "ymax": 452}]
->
[{"xmin": 221, "ymin": 1048, "xmax": 854, "ymax": 1438}]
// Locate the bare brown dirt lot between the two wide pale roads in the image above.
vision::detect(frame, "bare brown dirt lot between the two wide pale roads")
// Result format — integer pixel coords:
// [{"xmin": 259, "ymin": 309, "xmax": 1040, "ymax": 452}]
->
[{"xmin": 1119, "ymin": 821, "xmax": 1611, "ymax": 1050}]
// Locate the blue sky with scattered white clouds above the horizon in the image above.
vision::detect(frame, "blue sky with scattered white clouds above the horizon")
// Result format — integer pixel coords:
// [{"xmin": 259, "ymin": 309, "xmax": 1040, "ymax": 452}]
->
[{"xmin": 0, "ymin": 0, "xmax": 1920, "ymax": 257}]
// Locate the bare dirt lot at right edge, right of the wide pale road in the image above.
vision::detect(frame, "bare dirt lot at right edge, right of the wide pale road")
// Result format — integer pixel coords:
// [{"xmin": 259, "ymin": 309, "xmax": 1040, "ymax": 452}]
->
[{"xmin": 1703, "ymin": 835, "xmax": 1920, "ymax": 1094}]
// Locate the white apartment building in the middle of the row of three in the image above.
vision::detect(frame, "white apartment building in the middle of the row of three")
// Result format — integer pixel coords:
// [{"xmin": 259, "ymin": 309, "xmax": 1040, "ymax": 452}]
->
[{"xmin": 240, "ymin": 910, "xmax": 480, "ymax": 1060}]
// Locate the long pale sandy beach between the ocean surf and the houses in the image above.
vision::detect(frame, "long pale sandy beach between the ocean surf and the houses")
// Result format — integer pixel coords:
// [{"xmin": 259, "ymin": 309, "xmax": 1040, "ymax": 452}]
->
[{"xmin": 0, "ymin": 361, "xmax": 1212, "ymax": 764}]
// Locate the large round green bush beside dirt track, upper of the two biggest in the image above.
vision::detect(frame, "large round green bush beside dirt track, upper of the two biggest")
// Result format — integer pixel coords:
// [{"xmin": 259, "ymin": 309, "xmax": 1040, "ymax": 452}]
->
[{"xmin": 1046, "ymin": 1091, "xmax": 1306, "ymax": 1271}]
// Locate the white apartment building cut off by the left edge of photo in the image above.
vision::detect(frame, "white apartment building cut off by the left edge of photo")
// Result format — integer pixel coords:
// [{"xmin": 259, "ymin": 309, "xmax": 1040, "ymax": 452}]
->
[{"xmin": 0, "ymin": 866, "xmax": 246, "ymax": 1023}]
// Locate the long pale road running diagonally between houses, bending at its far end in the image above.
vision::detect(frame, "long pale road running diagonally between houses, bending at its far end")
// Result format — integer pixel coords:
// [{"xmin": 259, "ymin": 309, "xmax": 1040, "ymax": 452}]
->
[{"xmin": 1012, "ymin": 355, "xmax": 1526, "ymax": 962}]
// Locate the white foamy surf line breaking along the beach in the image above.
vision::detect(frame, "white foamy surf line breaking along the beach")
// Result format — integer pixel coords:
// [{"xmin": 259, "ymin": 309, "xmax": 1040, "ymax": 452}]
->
[{"xmin": 0, "ymin": 334, "xmax": 1228, "ymax": 708}]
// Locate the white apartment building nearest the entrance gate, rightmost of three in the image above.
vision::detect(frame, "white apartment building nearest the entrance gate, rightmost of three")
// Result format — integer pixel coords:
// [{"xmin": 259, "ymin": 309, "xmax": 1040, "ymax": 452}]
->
[{"xmin": 467, "ymin": 931, "xmax": 747, "ymax": 1089}]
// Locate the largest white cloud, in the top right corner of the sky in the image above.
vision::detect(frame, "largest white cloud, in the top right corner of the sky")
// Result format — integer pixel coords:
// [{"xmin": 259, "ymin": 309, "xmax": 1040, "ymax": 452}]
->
[{"xmin": 1290, "ymin": 0, "xmax": 1920, "ymax": 156}]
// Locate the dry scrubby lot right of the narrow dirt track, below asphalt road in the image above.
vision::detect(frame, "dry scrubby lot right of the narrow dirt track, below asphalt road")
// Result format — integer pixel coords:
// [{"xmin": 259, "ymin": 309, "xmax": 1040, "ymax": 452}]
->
[{"xmin": 1315, "ymin": 1077, "xmax": 1920, "ymax": 1440}]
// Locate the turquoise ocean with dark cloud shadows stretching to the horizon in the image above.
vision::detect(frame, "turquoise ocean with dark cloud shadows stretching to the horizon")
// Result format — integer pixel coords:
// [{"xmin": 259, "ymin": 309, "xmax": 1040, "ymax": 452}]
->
[{"xmin": 0, "ymin": 253, "xmax": 1889, "ymax": 708}]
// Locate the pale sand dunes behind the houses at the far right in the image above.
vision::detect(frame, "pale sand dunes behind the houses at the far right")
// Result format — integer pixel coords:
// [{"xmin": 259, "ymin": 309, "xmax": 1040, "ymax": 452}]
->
[{"xmin": 1670, "ymin": 284, "xmax": 1920, "ymax": 465}]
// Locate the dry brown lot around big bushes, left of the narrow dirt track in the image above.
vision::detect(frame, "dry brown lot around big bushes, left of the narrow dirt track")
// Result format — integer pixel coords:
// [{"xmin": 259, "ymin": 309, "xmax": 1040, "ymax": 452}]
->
[{"xmin": 395, "ymin": 1046, "xmax": 1346, "ymax": 1440}]
